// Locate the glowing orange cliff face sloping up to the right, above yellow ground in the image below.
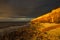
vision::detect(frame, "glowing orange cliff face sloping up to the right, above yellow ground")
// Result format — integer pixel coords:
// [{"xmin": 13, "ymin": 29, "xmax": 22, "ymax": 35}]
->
[{"xmin": 31, "ymin": 8, "xmax": 60, "ymax": 23}]
